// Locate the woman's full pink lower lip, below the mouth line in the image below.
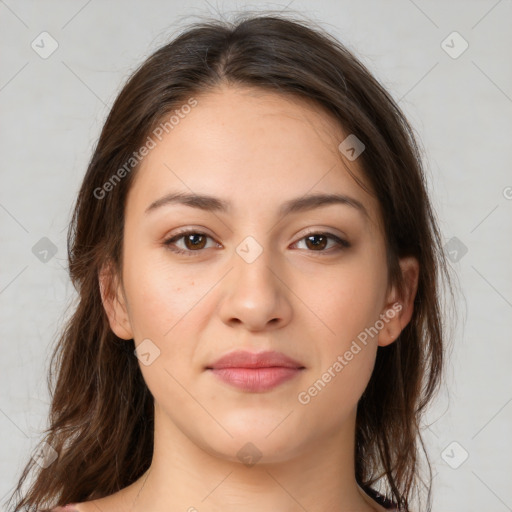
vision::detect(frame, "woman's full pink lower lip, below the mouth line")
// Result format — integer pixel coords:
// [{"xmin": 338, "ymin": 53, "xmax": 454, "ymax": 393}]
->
[{"xmin": 210, "ymin": 366, "xmax": 301, "ymax": 393}]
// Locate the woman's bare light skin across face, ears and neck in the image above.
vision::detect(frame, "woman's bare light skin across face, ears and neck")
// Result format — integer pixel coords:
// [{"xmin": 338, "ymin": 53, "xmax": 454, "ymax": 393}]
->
[{"xmin": 81, "ymin": 86, "xmax": 418, "ymax": 512}]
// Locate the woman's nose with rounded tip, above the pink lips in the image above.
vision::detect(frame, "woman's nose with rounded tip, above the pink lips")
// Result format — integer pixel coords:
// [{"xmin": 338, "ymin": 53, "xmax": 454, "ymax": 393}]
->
[{"xmin": 219, "ymin": 240, "xmax": 293, "ymax": 331}]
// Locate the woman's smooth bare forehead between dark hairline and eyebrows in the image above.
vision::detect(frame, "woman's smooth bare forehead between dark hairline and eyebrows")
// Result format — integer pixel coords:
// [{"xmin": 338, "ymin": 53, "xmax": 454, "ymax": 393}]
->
[{"xmin": 128, "ymin": 86, "xmax": 380, "ymax": 234}]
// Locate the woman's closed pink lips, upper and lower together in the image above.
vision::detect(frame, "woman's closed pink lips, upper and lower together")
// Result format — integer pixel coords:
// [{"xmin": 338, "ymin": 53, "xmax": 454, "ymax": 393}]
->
[{"xmin": 206, "ymin": 350, "xmax": 304, "ymax": 393}]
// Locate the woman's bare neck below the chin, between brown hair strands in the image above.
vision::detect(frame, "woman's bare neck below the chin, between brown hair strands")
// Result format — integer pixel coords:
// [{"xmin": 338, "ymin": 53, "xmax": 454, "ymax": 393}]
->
[{"xmin": 126, "ymin": 407, "xmax": 377, "ymax": 512}]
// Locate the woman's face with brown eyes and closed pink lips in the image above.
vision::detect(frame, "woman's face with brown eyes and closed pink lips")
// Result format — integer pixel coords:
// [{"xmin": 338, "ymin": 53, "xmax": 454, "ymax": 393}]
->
[{"xmin": 103, "ymin": 87, "xmax": 416, "ymax": 462}]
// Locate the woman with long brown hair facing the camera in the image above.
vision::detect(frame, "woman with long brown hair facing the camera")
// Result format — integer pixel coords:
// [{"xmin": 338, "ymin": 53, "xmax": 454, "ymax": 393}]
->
[{"xmin": 5, "ymin": 15, "xmax": 449, "ymax": 512}]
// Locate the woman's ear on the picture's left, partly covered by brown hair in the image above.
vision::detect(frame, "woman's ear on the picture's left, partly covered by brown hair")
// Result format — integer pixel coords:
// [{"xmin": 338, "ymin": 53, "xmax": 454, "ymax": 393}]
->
[{"xmin": 98, "ymin": 263, "xmax": 133, "ymax": 340}]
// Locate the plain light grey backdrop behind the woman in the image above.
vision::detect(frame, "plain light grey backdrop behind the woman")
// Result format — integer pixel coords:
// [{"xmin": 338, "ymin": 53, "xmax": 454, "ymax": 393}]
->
[{"xmin": 0, "ymin": 0, "xmax": 512, "ymax": 512}]
